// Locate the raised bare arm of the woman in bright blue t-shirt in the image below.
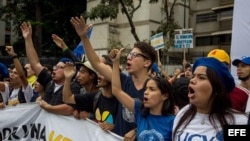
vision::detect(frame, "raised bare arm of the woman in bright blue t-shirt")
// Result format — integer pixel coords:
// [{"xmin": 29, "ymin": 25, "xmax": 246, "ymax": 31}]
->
[{"xmin": 109, "ymin": 49, "xmax": 134, "ymax": 112}]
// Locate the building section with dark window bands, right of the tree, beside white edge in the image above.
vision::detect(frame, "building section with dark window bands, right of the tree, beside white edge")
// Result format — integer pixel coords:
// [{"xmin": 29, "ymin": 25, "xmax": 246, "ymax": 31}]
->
[{"xmin": 187, "ymin": 0, "xmax": 234, "ymax": 61}]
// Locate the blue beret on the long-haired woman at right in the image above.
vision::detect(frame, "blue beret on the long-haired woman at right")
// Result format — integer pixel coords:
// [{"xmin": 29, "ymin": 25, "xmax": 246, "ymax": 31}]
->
[{"xmin": 192, "ymin": 57, "xmax": 235, "ymax": 93}]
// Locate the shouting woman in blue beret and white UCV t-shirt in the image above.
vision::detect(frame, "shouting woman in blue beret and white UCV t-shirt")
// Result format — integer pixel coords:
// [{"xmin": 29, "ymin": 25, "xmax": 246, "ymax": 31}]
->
[{"xmin": 173, "ymin": 58, "xmax": 247, "ymax": 141}]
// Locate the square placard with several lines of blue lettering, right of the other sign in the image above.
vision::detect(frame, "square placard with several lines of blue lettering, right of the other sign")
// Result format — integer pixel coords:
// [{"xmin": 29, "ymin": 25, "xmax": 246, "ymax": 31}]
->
[{"xmin": 174, "ymin": 29, "xmax": 193, "ymax": 48}]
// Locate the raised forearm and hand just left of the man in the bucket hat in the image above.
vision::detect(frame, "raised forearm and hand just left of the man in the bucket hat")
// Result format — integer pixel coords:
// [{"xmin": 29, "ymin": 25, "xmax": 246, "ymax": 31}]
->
[{"xmin": 63, "ymin": 63, "xmax": 76, "ymax": 104}]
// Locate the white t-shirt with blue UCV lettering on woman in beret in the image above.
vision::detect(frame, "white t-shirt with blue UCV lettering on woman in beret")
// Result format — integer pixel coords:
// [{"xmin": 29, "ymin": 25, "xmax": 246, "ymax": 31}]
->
[{"xmin": 173, "ymin": 105, "xmax": 247, "ymax": 141}]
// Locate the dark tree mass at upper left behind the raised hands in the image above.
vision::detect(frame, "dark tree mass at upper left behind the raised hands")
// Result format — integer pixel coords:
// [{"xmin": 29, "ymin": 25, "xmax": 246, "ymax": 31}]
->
[{"xmin": 0, "ymin": 0, "xmax": 86, "ymax": 56}]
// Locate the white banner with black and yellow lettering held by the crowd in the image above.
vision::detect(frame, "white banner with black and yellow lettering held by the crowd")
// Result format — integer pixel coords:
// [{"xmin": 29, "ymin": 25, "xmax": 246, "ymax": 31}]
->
[{"xmin": 0, "ymin": 103, "xmax": 123, "ymax": 141}]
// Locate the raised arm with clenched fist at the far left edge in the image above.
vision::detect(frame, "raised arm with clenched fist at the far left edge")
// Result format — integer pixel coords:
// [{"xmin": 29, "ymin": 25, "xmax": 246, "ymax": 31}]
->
[{"xmin": 5, "ymin": 46, "xmax": 29, "ymax": 88}]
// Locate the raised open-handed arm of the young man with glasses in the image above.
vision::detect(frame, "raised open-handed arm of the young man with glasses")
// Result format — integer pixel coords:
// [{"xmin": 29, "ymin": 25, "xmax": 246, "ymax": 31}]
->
[{"xmin": 70, "ymin": 16, "xmax": 112, "ymax": 81}]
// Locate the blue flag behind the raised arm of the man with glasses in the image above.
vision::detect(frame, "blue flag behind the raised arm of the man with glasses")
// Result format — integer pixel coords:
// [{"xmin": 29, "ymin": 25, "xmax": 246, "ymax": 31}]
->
[{"xmin": 73, "ymin": 27, "xmax": 93, "ymax": 61}]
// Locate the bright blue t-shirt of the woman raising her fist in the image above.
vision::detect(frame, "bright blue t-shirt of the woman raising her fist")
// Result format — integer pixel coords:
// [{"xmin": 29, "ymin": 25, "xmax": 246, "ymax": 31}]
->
[{"xmin": 135, "ymin": 100, "xmax": 175, "ymax": 141}]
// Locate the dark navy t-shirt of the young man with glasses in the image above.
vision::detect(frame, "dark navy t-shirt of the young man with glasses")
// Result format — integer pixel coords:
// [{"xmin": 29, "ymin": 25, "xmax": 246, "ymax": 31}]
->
[{"xmin": 113, "ymin": 73, "xmax": 144, "ymax": 136}]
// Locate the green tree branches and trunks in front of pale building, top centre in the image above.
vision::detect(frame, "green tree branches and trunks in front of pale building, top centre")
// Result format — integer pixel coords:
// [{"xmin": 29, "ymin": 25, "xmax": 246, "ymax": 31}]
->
[{"xmin": 83, "ymin": 0, "xmax": 181, "ymax": 50}]
